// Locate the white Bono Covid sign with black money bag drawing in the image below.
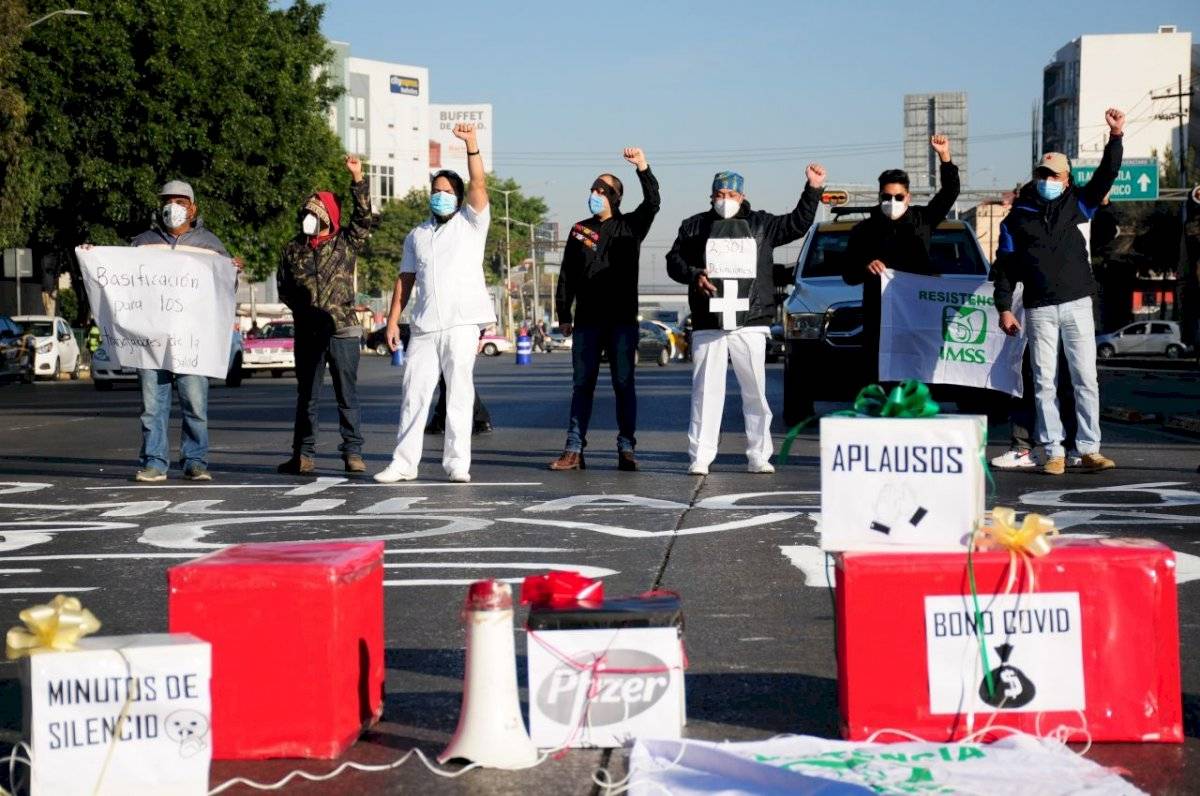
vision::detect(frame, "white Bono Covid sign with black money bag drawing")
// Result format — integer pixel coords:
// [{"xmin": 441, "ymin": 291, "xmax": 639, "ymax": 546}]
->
[{"xmin": 925, "ymin": 592, "xmax": 1087, "ymax": 714}]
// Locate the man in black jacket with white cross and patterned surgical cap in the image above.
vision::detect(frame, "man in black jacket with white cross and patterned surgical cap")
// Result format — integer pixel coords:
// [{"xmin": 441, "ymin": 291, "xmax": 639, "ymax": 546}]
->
[{"xmin": 667, "ymin": 163, "xmax": 826, "ymax": 475}]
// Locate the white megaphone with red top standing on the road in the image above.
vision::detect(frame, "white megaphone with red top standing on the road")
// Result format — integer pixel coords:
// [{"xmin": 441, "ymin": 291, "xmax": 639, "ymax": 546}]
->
[{"xmin": 438, "ymin": 580, "xmax": 538, "ymax": 770}]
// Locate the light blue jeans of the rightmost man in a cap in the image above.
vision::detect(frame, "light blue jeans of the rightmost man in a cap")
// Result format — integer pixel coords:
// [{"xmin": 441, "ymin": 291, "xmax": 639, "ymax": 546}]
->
[{"xmin": 1025, "ymin": 297, "xmax": 1100, "ymax": 456}]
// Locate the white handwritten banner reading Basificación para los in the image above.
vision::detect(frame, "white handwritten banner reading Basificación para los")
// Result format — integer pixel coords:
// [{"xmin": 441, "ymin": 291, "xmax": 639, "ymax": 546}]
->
[{"xmin": 76, "ymin": 246, "xmax": 238, "ymax": 378}]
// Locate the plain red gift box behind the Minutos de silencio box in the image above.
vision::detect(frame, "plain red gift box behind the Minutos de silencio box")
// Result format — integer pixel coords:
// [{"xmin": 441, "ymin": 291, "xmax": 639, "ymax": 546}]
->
[{"xmin": 167, "ymin": 541, "xmax": 384, "ymax": 760}]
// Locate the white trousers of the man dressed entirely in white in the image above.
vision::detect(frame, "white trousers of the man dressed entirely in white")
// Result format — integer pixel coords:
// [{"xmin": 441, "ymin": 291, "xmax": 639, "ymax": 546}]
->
[{"xmin": 391, "ymin": 324, "xmax": 479, "ymax": 475}]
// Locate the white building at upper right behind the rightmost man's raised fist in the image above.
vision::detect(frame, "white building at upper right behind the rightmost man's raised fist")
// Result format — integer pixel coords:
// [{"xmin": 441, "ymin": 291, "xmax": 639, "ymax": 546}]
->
[{"xmin": 1042, "ymin": 25, "xmax": 1193, "ymax": 161}]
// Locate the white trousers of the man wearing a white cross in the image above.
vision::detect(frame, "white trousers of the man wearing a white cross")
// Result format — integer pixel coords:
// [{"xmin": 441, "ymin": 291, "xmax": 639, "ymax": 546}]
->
[{"xmin": 688, "ymin": 327, "xmax": 775, "ymax": 467}]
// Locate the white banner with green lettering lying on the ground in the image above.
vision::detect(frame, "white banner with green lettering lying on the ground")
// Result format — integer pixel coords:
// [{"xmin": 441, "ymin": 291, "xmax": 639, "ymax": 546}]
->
[{"xmin": 629, "ymin": 735, "xmax": 1142, "ymax": 796}]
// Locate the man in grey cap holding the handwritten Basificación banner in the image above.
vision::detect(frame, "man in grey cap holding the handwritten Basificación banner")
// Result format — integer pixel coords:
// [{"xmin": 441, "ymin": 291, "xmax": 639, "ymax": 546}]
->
[{"xmin": 131, "ymin": 180, "xmax": 241, "ymax": 483}]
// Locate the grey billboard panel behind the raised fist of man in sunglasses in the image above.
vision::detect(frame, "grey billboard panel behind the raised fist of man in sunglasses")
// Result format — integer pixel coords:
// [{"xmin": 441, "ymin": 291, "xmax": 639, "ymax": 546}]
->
[{"xmin": 904, "ymin": 91, "xmax": 970, "ymax": 188}]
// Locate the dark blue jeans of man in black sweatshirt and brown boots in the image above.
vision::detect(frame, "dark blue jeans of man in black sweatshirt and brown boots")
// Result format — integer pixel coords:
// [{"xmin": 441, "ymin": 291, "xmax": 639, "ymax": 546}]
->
[{"xmin": 564, "ymin": 323, "xmax": 638, "ymax": 453}]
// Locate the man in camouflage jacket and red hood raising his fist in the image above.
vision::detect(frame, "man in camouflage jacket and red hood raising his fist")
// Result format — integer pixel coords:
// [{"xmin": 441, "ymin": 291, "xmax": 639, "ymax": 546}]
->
[{"xmin": 276, "ymin": 155, "xmax": 371, "ymax": 475}]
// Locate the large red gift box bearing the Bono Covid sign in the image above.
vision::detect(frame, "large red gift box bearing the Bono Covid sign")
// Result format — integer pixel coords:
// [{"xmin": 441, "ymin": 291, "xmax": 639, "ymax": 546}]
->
[{"xmin": 836, "ymin": 537, "xmax": 1183, "ymax": 743}]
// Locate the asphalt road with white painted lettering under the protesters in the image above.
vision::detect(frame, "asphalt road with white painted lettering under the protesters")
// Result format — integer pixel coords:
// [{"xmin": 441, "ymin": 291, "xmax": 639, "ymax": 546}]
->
[{"xmin": 0, "ymin": 354, "xmax": 1200, "ymax": 794}]
